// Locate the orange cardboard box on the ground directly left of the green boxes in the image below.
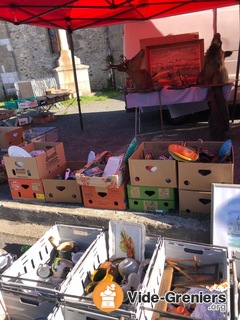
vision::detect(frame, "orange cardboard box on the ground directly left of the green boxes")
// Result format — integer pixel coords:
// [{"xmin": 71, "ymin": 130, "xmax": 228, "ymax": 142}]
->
[{"xmin": 81, "ymin": 182, "xmax": 127, "ymax": 210}]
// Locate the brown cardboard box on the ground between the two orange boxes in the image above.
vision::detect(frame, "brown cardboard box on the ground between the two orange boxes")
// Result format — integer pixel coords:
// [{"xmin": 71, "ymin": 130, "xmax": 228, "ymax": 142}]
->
[{"xmin": 42, "ymin": 161, "xmax": 85, "ymax": 204}]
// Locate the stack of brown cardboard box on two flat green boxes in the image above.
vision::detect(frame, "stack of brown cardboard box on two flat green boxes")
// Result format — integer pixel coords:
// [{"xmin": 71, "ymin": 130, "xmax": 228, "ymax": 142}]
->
[{"xmin": 127, "ymin": 141, "xmax": 177, "ymax": 212}]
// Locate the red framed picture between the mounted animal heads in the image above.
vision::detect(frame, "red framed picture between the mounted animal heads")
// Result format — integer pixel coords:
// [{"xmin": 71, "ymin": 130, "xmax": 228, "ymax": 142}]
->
[{"xmin": 146, "ymin": 39, "xmax": 204, "ymax": 85}]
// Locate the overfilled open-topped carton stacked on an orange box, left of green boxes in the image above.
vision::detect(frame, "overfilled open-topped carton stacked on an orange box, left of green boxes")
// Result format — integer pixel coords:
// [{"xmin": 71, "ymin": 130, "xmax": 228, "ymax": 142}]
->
[{"xmin": 76, "ymin": 151, "xmax": 129, "ymax": 210}]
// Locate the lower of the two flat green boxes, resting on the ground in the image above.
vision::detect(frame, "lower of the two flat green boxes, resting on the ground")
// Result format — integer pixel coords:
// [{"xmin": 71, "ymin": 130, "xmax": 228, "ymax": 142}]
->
[{"xmin": 128, "ymin": 198, "xmax": 176, "ymax": 213}]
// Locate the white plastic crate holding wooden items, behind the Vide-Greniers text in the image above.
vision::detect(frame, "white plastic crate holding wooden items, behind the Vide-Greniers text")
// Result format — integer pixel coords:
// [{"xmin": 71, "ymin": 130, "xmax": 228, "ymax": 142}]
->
[{"xmin": 137, "ymin": 238, "xmax": 230, "ymax": 320}]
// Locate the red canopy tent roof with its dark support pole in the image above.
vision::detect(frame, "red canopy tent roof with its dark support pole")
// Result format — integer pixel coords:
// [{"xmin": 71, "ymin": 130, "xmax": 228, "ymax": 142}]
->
[{"xmin": 0, "ymin": 0, "xmax": 240, "ymax": 128}]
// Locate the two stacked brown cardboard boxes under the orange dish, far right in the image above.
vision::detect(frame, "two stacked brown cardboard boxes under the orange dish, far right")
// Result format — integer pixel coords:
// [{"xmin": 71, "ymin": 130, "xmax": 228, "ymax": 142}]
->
[{"xmin": 178, "ymin": 141, "xmax": 234, "ymax": 218}]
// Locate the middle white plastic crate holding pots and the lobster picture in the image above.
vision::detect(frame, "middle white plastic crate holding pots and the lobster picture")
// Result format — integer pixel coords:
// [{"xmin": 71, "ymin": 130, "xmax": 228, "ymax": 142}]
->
[{"xmin": 58, "ymin": 232, "xmax": 159, "ymax": 320}]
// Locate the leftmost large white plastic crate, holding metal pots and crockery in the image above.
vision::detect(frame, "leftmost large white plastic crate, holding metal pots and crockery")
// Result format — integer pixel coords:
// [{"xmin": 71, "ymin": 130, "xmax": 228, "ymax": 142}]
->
[{"xmin": 0, "ymin": 224, "xmax": 105, "ymax": 320}]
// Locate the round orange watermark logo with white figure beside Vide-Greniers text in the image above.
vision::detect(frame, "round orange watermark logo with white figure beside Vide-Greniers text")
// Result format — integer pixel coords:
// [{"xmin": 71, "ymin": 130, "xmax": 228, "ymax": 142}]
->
[{"xmin": 92, "ymin": 281, "xmax": 124, "ymax": 312}]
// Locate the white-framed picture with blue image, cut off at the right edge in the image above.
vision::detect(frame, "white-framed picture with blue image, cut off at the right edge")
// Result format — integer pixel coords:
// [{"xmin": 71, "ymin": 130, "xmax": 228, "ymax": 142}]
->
[{"xmin": 211, "ymin": 183, "xmax": 240, "ymax": 255}]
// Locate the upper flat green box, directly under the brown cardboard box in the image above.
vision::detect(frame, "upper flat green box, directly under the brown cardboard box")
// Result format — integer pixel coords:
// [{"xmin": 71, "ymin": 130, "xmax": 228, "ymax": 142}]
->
[{"xmin": 127, "ymin": 184, "xmax": 176, "ymax": 200}]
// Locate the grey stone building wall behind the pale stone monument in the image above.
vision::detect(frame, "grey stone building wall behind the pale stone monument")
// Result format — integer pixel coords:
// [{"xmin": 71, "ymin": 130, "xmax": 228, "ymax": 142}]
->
[{"xmin": 0, "ymin": 22, "xmax": 124, "ymax": 100}]
